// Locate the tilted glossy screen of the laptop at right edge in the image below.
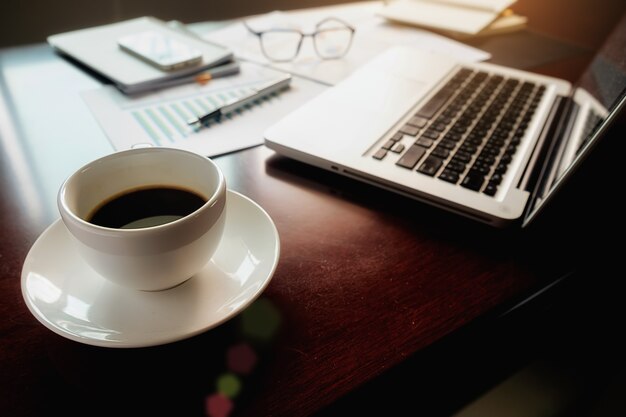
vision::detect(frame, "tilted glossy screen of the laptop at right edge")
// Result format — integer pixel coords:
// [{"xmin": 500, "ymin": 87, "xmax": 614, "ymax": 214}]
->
[{"xmin": 524, "ymin": 16, "xmax": 626, "ymax": 225}]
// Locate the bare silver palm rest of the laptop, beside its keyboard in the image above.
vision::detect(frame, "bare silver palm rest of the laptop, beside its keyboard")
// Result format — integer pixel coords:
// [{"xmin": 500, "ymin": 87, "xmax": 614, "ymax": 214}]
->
[{"xmin": 265, "ymin": 51, "xmax": 455, "ymax": 160}]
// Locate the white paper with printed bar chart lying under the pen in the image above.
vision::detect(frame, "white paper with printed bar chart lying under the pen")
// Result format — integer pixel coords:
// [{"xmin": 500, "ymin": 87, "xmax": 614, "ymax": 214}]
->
[{"xmin": 82, "ymin": 63, "xmax": 326, "ymax": 156}]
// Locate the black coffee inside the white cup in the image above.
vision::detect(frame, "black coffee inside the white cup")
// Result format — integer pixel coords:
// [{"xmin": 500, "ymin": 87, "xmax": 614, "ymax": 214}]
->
[{"xmin": 86, "ymin": 186, "xmax": 207, "ymax": 229}]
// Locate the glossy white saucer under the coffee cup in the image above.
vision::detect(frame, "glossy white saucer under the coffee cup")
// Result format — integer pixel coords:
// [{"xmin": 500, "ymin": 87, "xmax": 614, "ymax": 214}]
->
[{"xmin": 22, "ymin": 191, "xmax": 280, "ymax": 347}]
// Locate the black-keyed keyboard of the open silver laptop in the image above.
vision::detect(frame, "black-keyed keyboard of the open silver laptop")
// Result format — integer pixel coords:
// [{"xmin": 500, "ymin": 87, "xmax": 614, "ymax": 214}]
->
[{"xmin": 373, "ymin": 68, "xmax": 545, "ymax": 196}]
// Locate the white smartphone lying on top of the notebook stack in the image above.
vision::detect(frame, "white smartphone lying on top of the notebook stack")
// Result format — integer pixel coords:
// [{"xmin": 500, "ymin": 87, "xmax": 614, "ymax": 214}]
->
[{"xmin": 117, "ymin": 30, "xmax": 202, "ymax": 71}]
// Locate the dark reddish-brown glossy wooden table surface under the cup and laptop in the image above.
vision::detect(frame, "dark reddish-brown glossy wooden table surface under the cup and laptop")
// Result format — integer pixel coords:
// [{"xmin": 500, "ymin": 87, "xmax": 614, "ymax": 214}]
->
[{"xmin": 0, "ymin": 2, "xmax": 624, "ymax": 416}]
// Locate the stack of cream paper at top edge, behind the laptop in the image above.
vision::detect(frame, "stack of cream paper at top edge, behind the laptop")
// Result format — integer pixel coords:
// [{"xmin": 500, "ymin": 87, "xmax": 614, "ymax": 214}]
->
[{"xmin": 379, "ymin": 0, "xmax": 526, "ymax": 37}]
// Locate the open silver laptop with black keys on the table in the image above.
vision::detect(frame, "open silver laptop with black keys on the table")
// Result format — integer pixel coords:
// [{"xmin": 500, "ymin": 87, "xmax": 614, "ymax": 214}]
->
[{"xmin": 265, "ymin": 37, "xmax": 626, "ymax": 226}]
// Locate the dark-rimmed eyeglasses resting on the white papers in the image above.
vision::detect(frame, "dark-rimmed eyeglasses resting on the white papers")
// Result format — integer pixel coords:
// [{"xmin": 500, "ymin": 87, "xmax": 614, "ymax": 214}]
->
[{"xmin": 243, "ymin": 17, "xmax": 356, "ymax": 62}]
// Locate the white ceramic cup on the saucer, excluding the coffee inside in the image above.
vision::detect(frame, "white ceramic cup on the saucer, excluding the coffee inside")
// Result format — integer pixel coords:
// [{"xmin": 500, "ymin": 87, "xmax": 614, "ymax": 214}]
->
[{"xmin": 57, "ymin": 148, "xmax": 226, "ymax": 291}]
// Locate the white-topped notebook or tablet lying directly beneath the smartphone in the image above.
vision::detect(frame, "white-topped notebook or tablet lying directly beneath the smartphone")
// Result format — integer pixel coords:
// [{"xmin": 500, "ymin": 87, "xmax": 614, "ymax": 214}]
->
[{"xmin": 48, "ymin": 17, "xmax": 233, "ymax": 93}]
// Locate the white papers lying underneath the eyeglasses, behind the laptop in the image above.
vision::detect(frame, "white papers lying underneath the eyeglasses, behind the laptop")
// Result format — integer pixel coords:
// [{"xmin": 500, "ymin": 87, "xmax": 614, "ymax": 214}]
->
[{"xmin": 203, "ymin": 2, "xmax": 490, "ymax": 85}]
